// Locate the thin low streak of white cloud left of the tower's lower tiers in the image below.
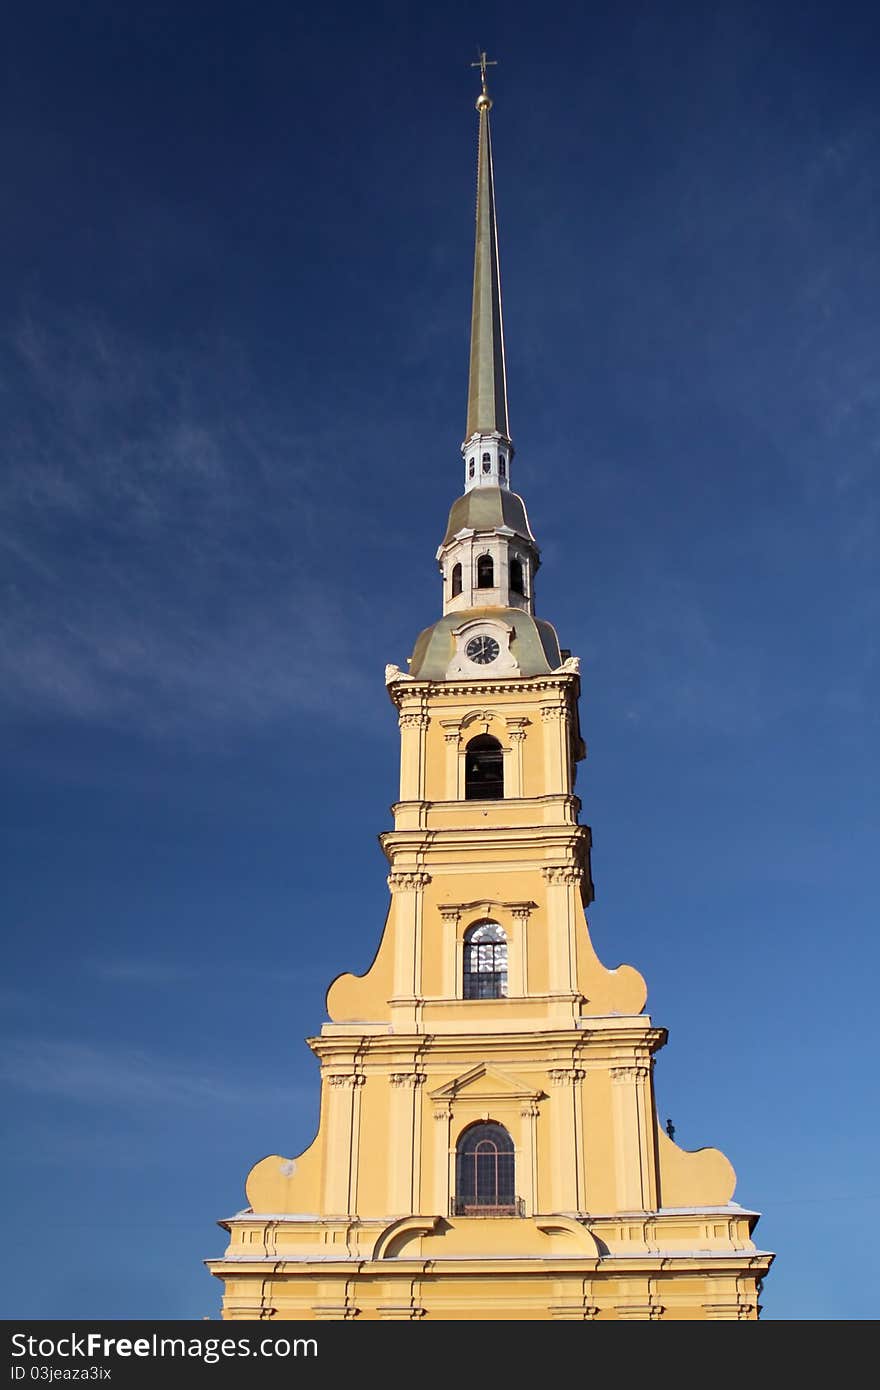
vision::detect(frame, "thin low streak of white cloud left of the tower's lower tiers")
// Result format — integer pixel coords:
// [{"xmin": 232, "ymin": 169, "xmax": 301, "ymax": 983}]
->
[{"xmin": 0, "ymin": 1037, "xmax": 291, "ymax": 1108}]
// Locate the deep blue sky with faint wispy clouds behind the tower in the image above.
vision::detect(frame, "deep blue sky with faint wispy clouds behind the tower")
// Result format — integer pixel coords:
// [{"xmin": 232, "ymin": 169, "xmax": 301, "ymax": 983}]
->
[{"xmin": 0, "ymin": 0, "xmax": 880, "ymax": 1319}]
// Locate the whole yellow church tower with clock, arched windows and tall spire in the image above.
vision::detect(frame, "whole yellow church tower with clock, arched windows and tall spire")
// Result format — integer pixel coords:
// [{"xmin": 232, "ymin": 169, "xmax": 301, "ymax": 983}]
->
[{"xmin": 207, "ymin": 67, "xmax": 773, "ymax": 1321}]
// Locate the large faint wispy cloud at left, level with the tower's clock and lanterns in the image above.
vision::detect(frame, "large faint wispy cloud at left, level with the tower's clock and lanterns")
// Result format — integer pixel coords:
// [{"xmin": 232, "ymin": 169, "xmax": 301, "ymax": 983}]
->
[{"xmin": 0, "ymin": 309, "xmax": 378, "ymax": 731}]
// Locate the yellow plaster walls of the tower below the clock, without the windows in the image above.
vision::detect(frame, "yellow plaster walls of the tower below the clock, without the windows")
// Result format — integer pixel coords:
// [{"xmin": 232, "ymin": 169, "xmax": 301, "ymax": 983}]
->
[{"xmin": 211, "ymin": 677, "xmax": 772, "ymax": 1321}]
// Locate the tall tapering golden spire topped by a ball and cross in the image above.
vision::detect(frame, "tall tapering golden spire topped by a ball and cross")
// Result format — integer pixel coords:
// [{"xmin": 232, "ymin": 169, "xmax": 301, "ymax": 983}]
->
[{"xmin": 466, "ymin": 53, "xmax": 509, "ymax": 442}]
